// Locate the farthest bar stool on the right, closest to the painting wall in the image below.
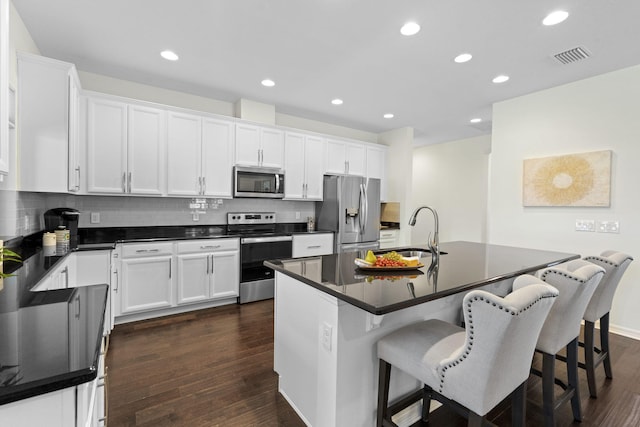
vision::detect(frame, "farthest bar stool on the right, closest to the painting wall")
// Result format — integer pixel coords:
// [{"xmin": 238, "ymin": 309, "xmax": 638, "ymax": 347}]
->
[{"xmin": 579, "ymin": 251, "xmax": 633, "ymax": 397}]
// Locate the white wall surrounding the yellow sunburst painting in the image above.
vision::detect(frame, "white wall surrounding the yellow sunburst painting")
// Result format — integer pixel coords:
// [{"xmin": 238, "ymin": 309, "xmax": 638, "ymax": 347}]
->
[{"xmin": 489, "ymin": 66, "xmax": 640, "ymax": 339}]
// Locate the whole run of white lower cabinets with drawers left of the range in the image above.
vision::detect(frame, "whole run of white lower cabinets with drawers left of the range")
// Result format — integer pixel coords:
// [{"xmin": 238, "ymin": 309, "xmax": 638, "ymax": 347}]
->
[{"xmin": 111, "ymin": 238, "xmax": 240, "ymax": 323}]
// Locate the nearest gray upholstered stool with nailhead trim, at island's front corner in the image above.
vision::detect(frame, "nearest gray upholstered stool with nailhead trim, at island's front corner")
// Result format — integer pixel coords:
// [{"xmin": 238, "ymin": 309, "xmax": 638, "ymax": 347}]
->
[{"xmin": 377, "ymin": 275, "xmax": 558, "ymax": 426}]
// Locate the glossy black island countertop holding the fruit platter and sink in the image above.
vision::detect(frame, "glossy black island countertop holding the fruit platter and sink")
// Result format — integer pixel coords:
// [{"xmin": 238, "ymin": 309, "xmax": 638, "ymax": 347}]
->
[{"xmin": 265, "ymin": 242, "xmax": 580, "ymax": 315}]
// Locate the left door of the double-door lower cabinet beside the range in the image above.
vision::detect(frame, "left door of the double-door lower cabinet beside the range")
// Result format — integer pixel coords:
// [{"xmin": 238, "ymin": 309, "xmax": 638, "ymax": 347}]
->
[{"xmin": 177, "ymin": 254, "xmax": 212, "ymax": 304}]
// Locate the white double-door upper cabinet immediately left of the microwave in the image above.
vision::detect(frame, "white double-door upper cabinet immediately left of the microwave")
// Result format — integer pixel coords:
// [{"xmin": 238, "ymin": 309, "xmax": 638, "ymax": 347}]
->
[{"xmin": 167, "ymin": 112, "xmax": 234, "ymax": 198}]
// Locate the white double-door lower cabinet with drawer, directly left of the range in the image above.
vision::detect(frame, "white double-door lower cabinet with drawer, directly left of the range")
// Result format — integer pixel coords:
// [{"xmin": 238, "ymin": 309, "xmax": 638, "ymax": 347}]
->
[{"xmin": 177, "ymin": 239, "xmax": 240, "ymax": 304}]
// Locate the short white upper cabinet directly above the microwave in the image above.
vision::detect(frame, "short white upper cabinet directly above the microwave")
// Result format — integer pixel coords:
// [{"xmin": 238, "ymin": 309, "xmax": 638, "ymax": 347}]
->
[{"xmin": 235, "ymin": 123, "xmax": 284, "ymax": 168}]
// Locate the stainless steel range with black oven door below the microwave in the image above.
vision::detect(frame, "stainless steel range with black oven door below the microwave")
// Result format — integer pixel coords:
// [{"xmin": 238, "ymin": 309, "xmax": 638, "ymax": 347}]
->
[{"xmin": 227, "ymin": 212, "xmax": 293, "ymax": 304}]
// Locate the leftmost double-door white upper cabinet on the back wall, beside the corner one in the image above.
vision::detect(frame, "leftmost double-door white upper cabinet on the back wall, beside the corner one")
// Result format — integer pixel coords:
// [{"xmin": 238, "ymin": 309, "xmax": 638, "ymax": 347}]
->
[{"xmin": 87, "ymin": 93, "xmax": 166, "ymax": 196}]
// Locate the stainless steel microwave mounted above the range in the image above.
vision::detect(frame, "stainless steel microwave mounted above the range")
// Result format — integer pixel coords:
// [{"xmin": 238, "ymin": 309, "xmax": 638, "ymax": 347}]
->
[{"xmin": 233, "ymin": 166, "xmax": 284, "ymax": 199}]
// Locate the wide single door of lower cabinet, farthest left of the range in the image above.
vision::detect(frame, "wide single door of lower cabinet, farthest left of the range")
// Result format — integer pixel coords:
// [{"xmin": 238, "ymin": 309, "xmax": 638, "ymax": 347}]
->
[{"xmin": 120, "ymin": 256, "xmax": 172, "ymax": 314}]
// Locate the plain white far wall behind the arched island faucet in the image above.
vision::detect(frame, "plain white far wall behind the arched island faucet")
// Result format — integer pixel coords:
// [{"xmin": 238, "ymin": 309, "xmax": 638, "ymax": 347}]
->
[{"xmin": 411, "ymin": 135, "xmax": 491, "ymax": 244}]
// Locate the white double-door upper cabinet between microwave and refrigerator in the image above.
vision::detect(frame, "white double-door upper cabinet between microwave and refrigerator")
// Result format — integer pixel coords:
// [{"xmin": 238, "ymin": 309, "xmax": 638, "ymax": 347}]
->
[{"xmin": 284, "ymin": 132, "xmax": 325, "ymax": 200}]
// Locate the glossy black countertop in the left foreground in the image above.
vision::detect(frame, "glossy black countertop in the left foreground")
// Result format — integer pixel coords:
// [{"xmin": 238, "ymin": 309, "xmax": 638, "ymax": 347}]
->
[{"xmin": 0, "ymin": 236, "xmax": 108, "ymax": 405}]
